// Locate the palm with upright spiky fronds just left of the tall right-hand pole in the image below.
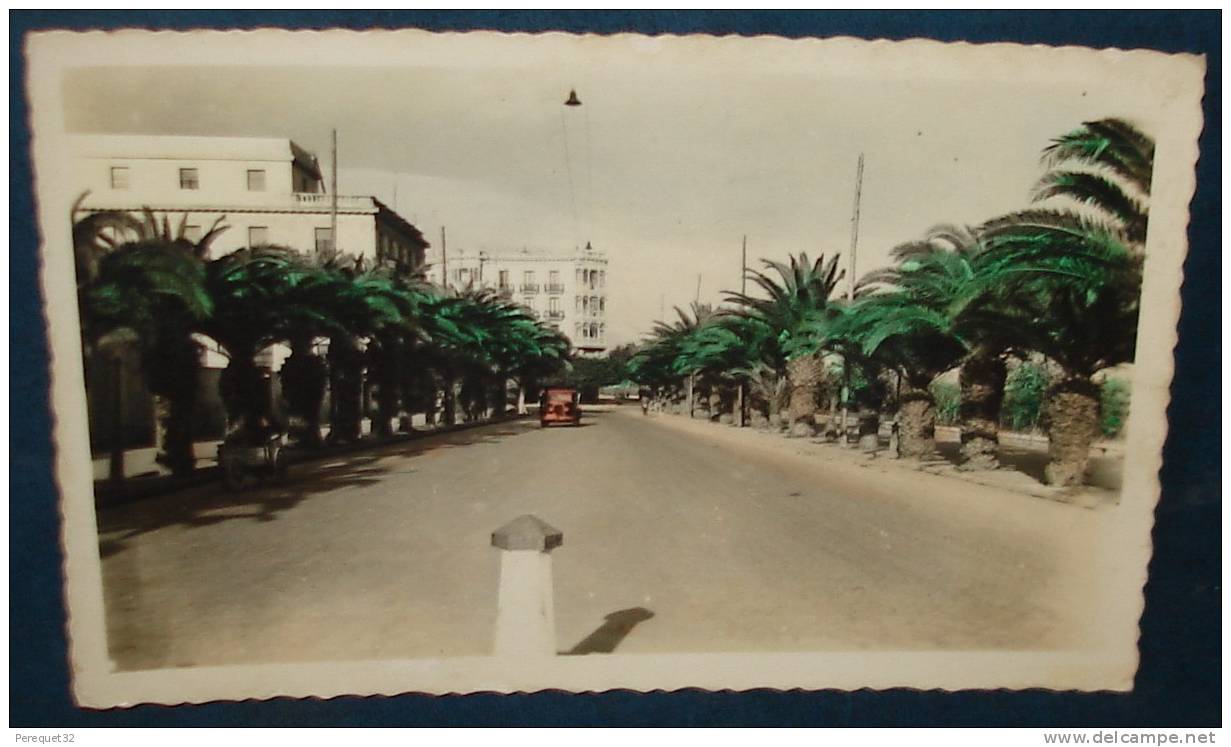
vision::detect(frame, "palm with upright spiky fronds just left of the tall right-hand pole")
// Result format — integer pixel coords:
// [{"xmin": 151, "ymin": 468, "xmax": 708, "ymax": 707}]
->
[{"xmin": 726, "ymin": 252, "xmax": 846, "ymax": 432}]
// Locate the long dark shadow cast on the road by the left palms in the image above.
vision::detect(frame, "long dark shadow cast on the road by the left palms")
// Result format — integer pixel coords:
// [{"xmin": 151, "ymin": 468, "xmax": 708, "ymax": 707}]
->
[{"xmin": 97, "ymin": 421, "xmax": 538, "ymax": 557}]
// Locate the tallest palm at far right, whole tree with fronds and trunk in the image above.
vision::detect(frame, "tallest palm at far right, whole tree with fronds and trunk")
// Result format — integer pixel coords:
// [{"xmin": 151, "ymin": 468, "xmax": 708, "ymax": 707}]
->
[{"xmin": 981, "ymin": 119, "xmax": 1153, "ymax": 486}]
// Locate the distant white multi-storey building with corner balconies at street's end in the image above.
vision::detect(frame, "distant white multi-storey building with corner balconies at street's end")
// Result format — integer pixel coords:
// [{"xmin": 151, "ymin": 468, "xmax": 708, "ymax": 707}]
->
[{"xmin": 427, "ymin": 242, "xmax": 607, "ymax": 356}]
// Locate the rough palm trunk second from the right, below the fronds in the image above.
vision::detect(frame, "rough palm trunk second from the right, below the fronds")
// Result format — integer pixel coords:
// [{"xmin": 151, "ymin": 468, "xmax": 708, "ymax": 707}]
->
[{"xmin": 958, "ymin": 351, "xmax": 1008, "ymax": 470}]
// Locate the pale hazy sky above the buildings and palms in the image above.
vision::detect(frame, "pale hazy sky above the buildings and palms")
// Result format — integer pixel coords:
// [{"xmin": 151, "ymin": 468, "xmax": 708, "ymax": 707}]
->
[{"xmin": 63, "ymin": 37, "xmax": 1149, "ymax": 343}]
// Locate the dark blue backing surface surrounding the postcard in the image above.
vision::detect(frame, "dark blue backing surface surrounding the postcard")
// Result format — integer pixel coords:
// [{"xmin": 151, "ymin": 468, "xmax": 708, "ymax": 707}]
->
[{"xmin": 9, "ymin": 11, "xmax": 1222, "ymax": 727}]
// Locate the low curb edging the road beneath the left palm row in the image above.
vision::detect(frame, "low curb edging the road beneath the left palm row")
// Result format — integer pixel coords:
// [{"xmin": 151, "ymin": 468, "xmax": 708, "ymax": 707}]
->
[{"xmin": 94, "ymin": 413, "xmax": 533, "ymax": 508}]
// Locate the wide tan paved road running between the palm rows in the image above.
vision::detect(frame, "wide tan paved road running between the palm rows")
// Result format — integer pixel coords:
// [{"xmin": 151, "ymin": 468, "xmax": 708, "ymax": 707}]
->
[{"xmin": 100, "ymin": 409, "xmax": 1097, "ymax": 669}]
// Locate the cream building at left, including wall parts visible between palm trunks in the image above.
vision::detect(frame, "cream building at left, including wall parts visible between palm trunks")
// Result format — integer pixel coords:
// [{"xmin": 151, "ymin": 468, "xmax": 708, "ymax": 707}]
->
[{"xmin": 71, "ymin": 135, "xmax": 428, "ymax": 462}]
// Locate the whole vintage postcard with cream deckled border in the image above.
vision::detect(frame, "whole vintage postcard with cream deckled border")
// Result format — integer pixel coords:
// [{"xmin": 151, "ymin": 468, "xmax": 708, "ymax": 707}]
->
[{"xmin": 26, "ymin": 30, "xmax": 1205, "ymax": 708}]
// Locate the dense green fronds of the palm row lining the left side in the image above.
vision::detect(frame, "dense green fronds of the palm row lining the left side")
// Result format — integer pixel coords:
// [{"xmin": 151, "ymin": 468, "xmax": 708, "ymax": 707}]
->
[{"xmin": 74, "ymin": 206, "xmax": 569, "ymax": 438}]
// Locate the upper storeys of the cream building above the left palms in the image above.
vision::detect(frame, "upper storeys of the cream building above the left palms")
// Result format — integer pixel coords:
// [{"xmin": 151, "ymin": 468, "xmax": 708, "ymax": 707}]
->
[{"xmin": 71, "ymin": 135, "xmax": 428, "ymax": 272}]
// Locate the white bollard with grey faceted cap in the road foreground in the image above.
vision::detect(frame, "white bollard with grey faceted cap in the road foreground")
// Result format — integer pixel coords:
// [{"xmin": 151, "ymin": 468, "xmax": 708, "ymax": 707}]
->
[{"xmin": 491, "ymin": 514, "xmax": 564, "ymax": 657}]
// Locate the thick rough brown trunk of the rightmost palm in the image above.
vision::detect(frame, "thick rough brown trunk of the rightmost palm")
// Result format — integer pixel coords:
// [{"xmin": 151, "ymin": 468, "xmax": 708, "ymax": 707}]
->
[{"xmin": 1044, "ymin": 377, "xmax": 1099, "ymax": 487}]
